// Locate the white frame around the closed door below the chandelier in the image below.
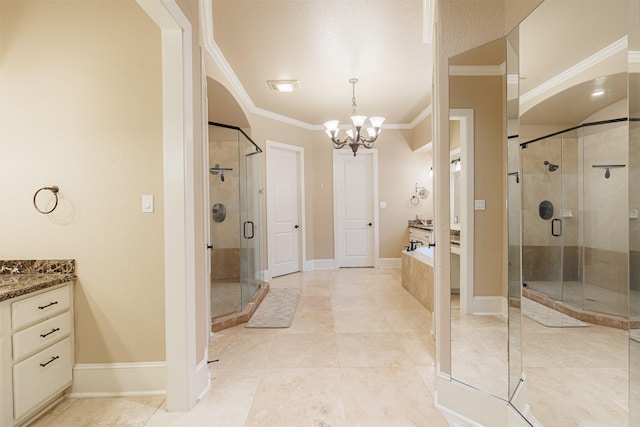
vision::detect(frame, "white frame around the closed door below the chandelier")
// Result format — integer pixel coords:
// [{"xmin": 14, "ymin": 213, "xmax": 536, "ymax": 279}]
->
[{"xmin": 333, "ymin": 148, "xmax": 380, "ymax": 268}]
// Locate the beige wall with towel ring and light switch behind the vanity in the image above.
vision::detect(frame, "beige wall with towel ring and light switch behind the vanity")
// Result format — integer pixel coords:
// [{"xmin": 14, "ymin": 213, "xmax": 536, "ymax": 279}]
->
[{"xmin": 0, "ymin": 1, "xmax": 165, "ymax": 363}]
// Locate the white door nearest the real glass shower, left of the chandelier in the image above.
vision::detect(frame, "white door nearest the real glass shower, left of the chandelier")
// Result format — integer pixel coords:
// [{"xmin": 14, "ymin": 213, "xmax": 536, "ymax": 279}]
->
[{"xmin": 267, "ymin": 143, "xmax": 302, "ymax": 277}]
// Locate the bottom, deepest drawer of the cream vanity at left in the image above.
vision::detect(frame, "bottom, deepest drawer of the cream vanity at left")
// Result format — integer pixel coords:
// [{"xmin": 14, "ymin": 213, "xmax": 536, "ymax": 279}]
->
[{"xmin": 13, "ymin": 338, "xmax": 72, "ymax": 419}]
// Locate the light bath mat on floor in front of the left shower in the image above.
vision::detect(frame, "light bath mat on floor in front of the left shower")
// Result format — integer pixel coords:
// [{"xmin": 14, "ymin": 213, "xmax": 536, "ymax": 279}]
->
[{"xmin": 247, "ymin": 288, "xmax": 302, "ymax": 328}]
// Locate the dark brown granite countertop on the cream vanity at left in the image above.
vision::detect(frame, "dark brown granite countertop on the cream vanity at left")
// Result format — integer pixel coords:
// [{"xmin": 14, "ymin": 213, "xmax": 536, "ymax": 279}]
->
[{"xmin": 0, "ymin": 259, "xmax": 77, "ymax": 301}]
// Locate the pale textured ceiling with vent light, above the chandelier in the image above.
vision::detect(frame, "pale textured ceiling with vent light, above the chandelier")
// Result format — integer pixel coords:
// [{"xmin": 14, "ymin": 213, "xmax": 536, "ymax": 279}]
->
[{"xmin": 212, "ymin": 0, "xmax": 432, "ymax": 127}]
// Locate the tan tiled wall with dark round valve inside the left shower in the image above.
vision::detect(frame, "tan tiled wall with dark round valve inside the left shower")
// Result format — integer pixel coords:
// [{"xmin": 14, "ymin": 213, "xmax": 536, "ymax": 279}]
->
[{"xmin": 209, "ymin": 138, "xmax": 240, "ymax": 280}]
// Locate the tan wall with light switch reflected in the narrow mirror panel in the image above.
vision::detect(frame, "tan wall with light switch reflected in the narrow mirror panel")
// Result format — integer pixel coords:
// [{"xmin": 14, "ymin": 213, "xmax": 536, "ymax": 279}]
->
[{"xmin": 449, "ymin": 76, "xmax": 506, "ymax": 296}]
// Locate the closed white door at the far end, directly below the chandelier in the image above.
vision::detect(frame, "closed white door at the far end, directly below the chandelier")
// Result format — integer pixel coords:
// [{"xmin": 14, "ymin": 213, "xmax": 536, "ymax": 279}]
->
[{"xmin": 333, "ymin": 151, "xmax": 377, "ymax": 267}]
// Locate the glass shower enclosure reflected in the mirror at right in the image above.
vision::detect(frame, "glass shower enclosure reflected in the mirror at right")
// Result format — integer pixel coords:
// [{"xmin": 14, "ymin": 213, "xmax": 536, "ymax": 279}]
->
[{"xmin": 520, "ymin": 119, "xmax": 629, "ymax": 318}]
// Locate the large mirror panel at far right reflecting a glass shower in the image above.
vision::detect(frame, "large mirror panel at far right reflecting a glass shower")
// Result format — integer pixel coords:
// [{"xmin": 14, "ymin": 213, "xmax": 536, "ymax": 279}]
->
[{"xmin": 507, "ymin": 0, "xmax": 640, "ymax": 426}]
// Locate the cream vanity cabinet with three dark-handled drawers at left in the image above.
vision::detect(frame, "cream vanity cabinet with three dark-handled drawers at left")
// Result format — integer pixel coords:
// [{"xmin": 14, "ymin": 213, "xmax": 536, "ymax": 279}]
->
[{"xmin": 0, "ymin": 283, "xmax": 73, "ymax": 427}]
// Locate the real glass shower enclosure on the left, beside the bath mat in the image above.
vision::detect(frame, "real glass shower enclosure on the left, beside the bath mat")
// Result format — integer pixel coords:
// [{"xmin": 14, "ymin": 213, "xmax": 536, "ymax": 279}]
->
[{"xmin": 208, "ymin": 122, "xmax": 264, "ymax": 319}]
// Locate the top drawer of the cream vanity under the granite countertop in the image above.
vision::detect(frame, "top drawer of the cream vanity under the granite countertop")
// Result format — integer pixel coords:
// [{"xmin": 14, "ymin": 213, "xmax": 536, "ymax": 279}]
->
[{"xmin": 11, "ymin": 286, "xmax": 71, "ymax": 330}]
